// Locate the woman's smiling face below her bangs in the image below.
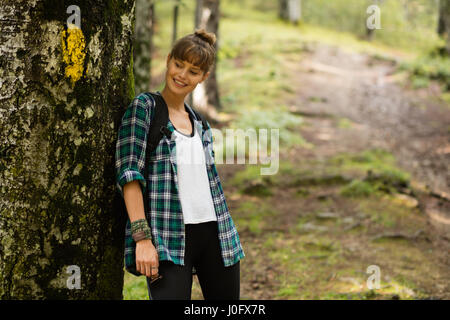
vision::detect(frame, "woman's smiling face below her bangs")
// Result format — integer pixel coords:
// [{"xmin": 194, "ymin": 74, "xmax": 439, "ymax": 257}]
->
[{"xmin": 166, "ymin": 55, "xmax": 209, "ymax": 95}]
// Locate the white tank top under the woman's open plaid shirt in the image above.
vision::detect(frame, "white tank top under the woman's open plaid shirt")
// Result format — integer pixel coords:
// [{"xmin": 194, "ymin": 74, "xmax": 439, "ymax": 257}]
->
[{"xmin": 173, "ymin": 126, "xmax": 217, "ymax": 224}]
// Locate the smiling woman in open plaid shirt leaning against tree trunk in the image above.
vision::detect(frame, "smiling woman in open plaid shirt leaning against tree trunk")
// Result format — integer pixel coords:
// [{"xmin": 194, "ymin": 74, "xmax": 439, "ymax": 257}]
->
[{"xmin": 116, "ymin": 30, "xmax": 244, "ymax": 300}]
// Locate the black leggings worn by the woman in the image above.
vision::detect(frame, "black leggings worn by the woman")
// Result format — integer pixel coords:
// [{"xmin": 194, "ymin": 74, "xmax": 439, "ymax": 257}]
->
[{"xmin": 147, "ymin": 221, "xmax": 240, "ymax": 300}]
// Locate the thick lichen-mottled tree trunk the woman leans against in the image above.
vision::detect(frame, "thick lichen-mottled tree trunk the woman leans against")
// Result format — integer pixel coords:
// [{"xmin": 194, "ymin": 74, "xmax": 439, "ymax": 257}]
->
[{"xmin": 0, "ymin": 0, "xmax": 135, "ymax": 299}]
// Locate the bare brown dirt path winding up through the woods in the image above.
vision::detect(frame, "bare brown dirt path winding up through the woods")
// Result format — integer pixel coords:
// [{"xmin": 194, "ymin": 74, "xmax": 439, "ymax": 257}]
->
[{"xmin": 291, "ymin": 45, "xmax": 450, "ymax": 232}]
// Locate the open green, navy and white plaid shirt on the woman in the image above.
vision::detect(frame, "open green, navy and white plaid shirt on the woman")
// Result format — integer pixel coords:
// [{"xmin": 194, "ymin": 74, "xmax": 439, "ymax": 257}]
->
[{"xmin": 115, "ymin": 91, "xmax": 245, "ymax": 266}]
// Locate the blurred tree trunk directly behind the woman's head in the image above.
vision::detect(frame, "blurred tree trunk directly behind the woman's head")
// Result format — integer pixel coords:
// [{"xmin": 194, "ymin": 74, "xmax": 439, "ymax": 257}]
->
[{"xmin": 192, "ymin": 0, "xmax": 222, "ymax": 123}]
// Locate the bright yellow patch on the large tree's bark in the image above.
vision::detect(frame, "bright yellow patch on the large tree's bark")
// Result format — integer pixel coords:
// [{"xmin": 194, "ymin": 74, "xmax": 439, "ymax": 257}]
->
[{"xmin": 61, "ymin": 24, "xmax": 86, "ymax": 87}]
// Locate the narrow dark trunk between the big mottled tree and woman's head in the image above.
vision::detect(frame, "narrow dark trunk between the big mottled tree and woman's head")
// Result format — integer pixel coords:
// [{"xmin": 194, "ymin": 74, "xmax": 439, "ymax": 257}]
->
[{"xmin": 133, "ymin": 0, "xmax": 155, "ymax": 94}]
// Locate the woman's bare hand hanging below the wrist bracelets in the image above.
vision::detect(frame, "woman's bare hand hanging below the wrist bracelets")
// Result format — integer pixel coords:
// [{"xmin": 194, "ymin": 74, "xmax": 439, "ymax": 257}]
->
[{"xmin": 136, "ymin": 239, "xmax": 159, "ymax": 277}]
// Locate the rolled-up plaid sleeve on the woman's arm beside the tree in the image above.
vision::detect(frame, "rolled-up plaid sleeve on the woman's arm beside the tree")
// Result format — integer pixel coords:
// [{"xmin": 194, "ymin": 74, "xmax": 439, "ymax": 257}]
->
[{"xmin": 115, "ymin": 95, "xmax": 150, "ymax": 197}]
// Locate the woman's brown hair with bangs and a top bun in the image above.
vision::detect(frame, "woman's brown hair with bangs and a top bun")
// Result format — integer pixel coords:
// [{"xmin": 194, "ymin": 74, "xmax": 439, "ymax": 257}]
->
[{"xmin": 170, "ymin": 29, "xmax": 216, "ymax": 73}]
